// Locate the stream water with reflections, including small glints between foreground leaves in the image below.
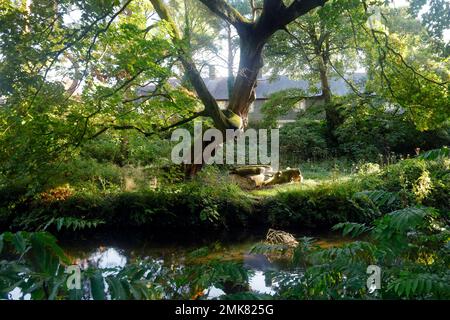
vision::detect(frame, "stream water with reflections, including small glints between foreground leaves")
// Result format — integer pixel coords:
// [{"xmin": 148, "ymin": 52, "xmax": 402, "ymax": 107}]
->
[{"xmin": 4, "ymin": 237, "xmax": 347, "ymax": 300}]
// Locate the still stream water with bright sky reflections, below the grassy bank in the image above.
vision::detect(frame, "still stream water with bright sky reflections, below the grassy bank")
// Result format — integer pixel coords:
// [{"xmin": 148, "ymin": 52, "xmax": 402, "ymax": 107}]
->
[{"xmin": 60, "ymin": 235, "xmax": 348, "ymax": 299}]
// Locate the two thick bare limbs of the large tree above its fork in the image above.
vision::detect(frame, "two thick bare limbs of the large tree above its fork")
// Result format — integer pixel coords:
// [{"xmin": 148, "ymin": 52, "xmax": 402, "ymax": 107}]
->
[{"xmin": 150, "ymin": 0, "xmax": 326, "ymax": 174}]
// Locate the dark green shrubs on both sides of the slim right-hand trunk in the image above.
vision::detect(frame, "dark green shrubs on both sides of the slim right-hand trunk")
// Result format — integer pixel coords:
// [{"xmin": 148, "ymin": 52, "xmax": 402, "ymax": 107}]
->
[{"xmin": 272, "ymin": 96, "xmax": 450, "ymax": 165}]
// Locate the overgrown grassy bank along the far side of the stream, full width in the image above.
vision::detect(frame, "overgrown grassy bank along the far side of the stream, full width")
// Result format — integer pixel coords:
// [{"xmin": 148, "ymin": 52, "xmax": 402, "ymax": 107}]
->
[{"xmin": 0, "ymin": 152, "xmax": 450, "ymax": 233}]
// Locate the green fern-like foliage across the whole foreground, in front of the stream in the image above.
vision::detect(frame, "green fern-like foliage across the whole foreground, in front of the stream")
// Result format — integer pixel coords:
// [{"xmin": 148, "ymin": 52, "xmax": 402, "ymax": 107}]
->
[{"xmin": 0, "ymin": 198, "xmax": 450, "ymax": 300}]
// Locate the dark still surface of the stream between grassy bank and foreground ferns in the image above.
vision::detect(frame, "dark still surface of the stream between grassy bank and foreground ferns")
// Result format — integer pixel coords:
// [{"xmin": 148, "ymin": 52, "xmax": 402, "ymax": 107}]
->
[{"xmin": 62, "ymin": 234, "xmax": 348, "ymax": 298}]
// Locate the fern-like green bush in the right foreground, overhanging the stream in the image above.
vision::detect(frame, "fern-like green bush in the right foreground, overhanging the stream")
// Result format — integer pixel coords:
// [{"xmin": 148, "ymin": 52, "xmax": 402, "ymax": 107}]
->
[{"xmin": 277, "ymin": 207, "xmax": 450, "ymax": 300}]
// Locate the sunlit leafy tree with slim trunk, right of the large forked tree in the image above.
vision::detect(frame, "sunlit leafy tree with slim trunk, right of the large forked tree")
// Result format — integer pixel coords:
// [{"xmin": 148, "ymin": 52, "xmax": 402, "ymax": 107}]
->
[{"xmin": 263, "ymin": 1, "xmax": 450, "ymax": 131}]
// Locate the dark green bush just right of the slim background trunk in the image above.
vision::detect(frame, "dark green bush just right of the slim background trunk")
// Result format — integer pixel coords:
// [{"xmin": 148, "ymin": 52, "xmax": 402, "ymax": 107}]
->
[{"xmin": 335, "ymin": 99, "xmax": 450, "ymax": 161}]
